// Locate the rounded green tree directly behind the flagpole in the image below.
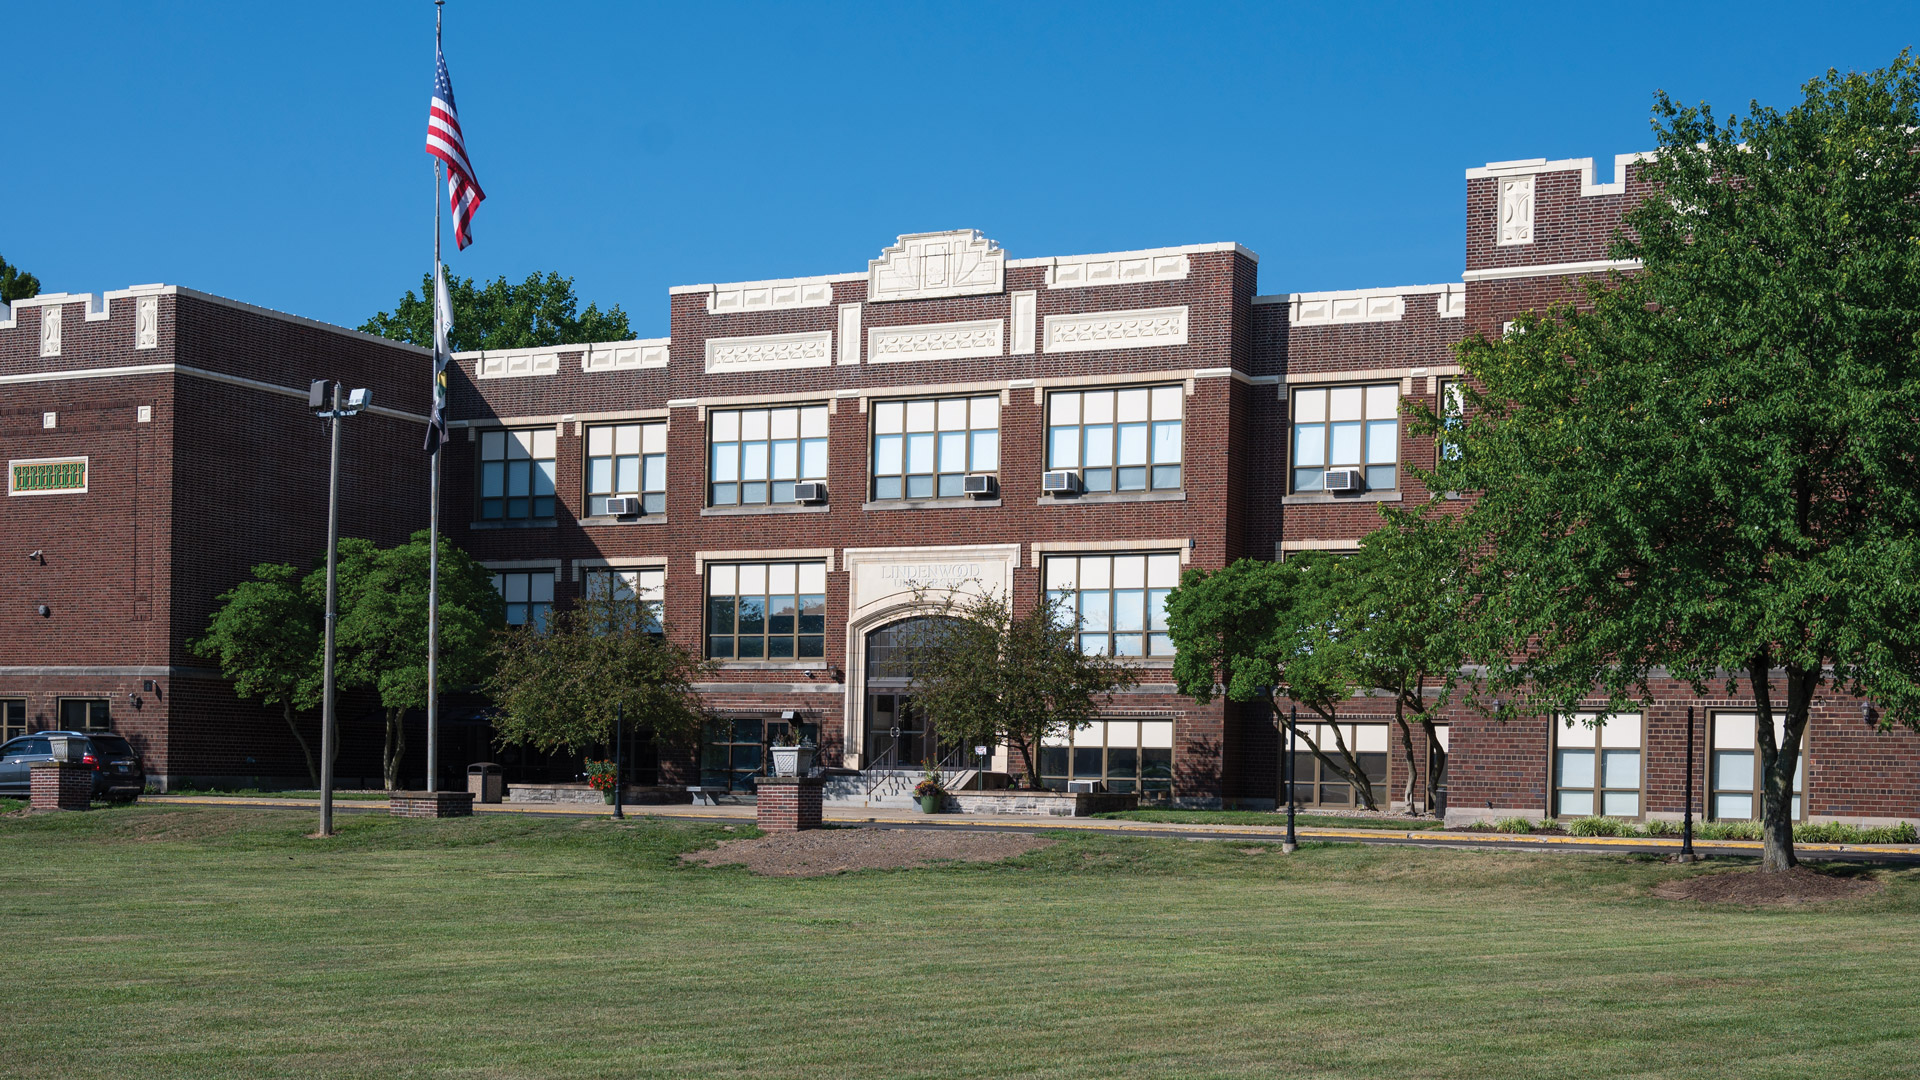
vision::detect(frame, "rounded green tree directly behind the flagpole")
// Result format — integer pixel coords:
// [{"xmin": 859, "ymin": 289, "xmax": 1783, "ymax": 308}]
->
[{"xmin": 324, "ymin": 530, "xmax": 507, "ymax": 790}]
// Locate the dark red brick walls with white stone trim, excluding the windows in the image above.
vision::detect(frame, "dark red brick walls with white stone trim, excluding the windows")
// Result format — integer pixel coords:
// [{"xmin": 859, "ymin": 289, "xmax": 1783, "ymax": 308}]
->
[{"xmin": 11, "ymin": 148, "xmax": 1920, "ymax": 821}]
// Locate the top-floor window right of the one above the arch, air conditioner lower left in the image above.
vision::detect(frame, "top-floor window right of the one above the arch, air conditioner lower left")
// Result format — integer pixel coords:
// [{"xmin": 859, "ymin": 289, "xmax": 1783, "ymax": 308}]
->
[{"xmin": 1046, "ymin": 386, "xmax": 1183, "ymax": 492}]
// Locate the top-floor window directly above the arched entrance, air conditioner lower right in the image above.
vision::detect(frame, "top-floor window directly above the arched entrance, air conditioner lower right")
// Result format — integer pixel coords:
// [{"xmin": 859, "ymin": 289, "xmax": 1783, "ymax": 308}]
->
[{"xmin": 874, "ymin": 394, "xmax": 1000, "ymax": 500}]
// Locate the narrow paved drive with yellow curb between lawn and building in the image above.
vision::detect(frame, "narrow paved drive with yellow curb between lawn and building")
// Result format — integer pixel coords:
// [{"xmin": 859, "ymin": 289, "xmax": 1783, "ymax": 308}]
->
[{"xmin": 142, "ymin": 796, "xmax": 1920, "ymax": 863}]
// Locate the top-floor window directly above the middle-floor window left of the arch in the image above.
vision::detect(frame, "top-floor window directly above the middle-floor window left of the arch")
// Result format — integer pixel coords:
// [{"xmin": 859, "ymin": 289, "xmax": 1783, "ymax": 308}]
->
[{"xmin": 707, "ymin": 405, "xmax": 828, "ymax": 505}]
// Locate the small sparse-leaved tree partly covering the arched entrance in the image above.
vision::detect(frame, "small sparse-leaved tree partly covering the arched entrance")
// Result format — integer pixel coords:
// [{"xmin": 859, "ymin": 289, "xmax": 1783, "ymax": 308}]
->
[{"xmin": 906, "ymin": 594, "xmax": 1135, "ymax": 788}]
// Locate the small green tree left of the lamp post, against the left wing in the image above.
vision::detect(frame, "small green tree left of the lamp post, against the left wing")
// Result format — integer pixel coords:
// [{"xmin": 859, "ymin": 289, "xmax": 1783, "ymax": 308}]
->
[{"xmin": 192, "ymin": 563, "xmax": 324, "ymax": 788}]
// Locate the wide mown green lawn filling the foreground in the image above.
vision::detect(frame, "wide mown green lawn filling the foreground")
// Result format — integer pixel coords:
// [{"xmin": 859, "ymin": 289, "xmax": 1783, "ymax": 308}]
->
[{"xmin": 0, "ymin": 805, "xmax": 1920, "ymax": 1080}]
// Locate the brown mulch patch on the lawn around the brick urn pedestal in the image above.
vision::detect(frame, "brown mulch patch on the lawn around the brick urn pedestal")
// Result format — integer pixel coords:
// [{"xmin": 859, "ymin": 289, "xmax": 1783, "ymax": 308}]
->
[{"xmin": 682, "ymin": 828, "xmax": 1052, "ymax": 878}]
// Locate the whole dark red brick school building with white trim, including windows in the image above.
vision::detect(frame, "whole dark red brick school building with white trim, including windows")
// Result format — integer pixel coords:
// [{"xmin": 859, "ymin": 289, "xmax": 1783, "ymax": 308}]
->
[{"xmin": 0, "ymin": 148, "xmax": 1920, "ymax": 821}]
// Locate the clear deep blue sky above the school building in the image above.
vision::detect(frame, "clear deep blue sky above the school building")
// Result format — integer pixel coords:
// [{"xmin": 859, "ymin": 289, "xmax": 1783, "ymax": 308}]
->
[{"xmin": 0, "ymin": 0, "xmax": 1920, "ymax": 336}]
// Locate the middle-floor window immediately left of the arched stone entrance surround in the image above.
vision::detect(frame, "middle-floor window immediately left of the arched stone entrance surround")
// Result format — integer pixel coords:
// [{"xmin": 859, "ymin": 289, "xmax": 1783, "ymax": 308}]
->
[{"xmin": 707, "ymin": 563, "xmax": 828, "ymax": 659}]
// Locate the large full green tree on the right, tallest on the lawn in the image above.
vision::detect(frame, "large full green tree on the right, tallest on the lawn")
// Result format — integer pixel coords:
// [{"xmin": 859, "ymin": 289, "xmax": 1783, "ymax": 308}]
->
[{"xmin": 1428, "ymin": 54, "xmax": 1920, "ymax": 871}]
